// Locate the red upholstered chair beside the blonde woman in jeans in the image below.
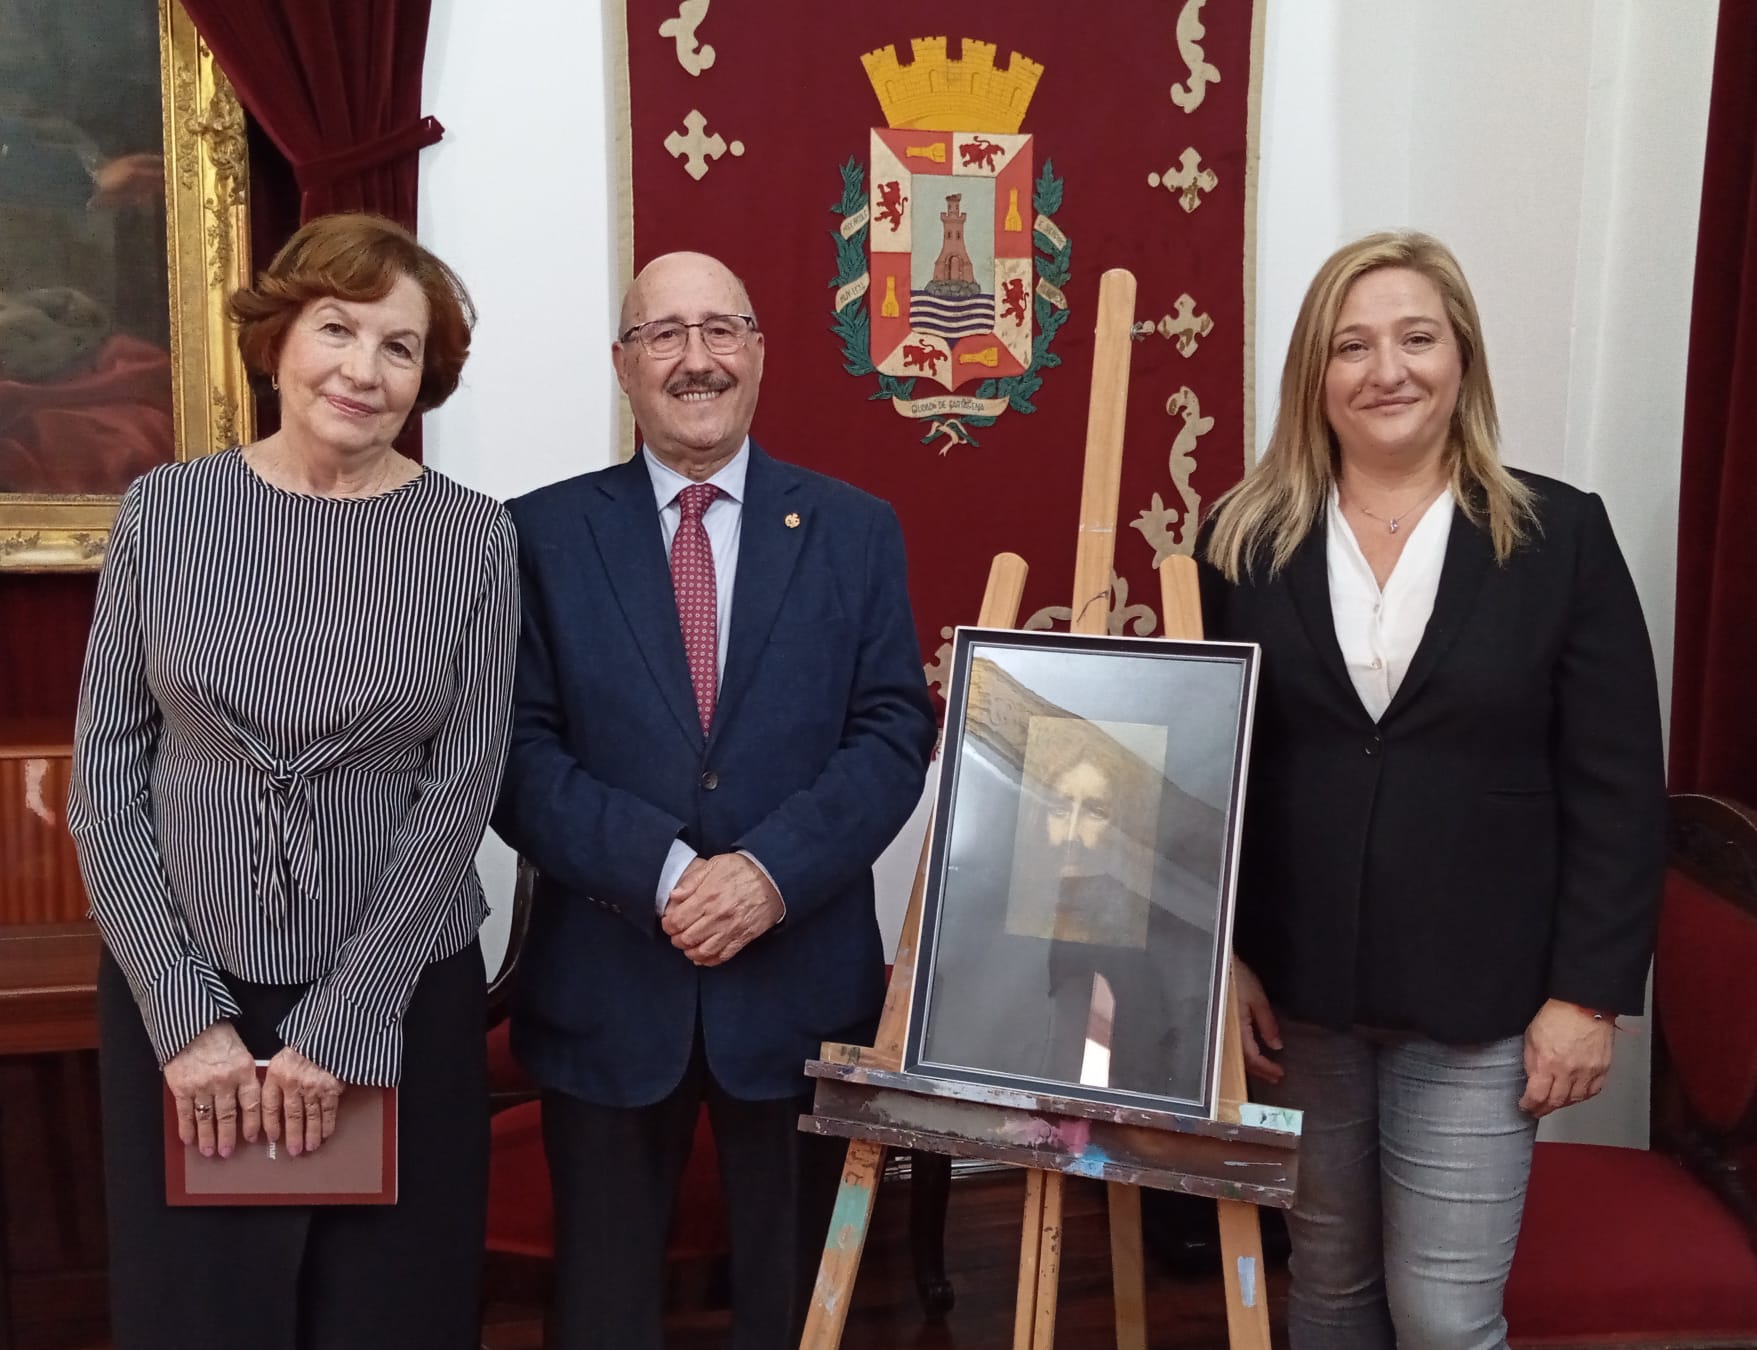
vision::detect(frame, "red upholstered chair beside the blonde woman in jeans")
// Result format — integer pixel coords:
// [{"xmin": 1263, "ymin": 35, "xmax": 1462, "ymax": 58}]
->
[{"xmin": 1506, "ymin": 796, "xmax": 1757, "ymax": 1350}]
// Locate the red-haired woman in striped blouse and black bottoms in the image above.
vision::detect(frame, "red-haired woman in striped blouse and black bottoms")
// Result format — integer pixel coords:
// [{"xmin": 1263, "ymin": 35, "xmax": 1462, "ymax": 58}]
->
[{"xmin": 70, "ymin": 214, "xmax": 518, "ymax": 1350}]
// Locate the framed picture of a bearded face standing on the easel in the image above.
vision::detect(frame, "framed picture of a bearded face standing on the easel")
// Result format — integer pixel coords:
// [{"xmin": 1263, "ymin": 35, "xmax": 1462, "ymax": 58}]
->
[{"xmin": 903, "ymin": 628, "xmax": 1258, "ymax": 1118}]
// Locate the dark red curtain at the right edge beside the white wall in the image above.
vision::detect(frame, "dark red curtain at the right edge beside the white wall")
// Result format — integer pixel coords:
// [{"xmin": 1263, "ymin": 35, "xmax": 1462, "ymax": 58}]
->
[{"xmin": 1671, "ymin": 0, "xmax": 1757, "ymax": 802}]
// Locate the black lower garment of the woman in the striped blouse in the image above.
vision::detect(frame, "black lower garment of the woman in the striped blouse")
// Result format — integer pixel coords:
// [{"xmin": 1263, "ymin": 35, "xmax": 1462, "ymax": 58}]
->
[{"xmin": 98, "ymin": 942, "xmax": 488, "ymax": 1350}]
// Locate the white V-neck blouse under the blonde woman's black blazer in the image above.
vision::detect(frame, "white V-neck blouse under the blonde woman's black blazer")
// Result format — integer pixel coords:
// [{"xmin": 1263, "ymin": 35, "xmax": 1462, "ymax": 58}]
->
[{"xmin": 1325, "ymin": 487, "xmax": 1453, "ymax": 721}]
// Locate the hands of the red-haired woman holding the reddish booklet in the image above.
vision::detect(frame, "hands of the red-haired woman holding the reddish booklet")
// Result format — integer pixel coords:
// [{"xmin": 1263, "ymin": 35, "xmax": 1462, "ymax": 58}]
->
[{"xmin": 165, "ymin": 1021, "xmax": 344, "ymax": 1158}]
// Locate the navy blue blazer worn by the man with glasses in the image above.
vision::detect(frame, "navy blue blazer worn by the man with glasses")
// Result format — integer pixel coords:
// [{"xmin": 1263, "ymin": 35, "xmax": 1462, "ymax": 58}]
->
[{"xmin": 494, "ymin": 445, "xmax": 935, "ymax": 1107}]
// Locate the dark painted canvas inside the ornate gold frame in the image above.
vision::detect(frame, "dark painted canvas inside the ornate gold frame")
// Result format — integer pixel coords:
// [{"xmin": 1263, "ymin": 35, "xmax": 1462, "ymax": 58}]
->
[{"xmin": 0, "ymin": 0, "xmax": 174, "ymax": 496}]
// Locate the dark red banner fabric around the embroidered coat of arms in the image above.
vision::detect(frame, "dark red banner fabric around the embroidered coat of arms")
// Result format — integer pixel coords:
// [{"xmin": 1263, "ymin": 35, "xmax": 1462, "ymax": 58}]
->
[{"xmin": 627, "ymin": 0, "xmax": 1251, "ymax": 675}]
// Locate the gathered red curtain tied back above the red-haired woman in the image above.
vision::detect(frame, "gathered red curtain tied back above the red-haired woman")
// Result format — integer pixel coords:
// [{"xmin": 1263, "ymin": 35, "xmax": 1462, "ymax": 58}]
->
[{"xmin": 183, "ymin": 0, "xmax": 445, "ymax": 228}]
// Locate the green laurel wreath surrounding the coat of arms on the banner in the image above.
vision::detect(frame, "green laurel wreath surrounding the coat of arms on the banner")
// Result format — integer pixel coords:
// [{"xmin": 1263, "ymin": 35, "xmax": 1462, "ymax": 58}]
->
[{"xmin": 829, "ymin": 158, "xmax": 1074, "ymax": 445}]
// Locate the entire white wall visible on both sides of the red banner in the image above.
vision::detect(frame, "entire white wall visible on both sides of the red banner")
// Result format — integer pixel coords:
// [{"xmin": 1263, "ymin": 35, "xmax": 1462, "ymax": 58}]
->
[{"xmin": 420, "ymin": 0, "xmax": 1715, "ymax": 1143}]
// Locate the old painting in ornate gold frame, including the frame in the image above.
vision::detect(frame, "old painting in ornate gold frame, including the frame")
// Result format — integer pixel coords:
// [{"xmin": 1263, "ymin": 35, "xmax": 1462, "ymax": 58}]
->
[{"xmin": 0, "ymin": 0, "xmax": 253, "ymax": 571}]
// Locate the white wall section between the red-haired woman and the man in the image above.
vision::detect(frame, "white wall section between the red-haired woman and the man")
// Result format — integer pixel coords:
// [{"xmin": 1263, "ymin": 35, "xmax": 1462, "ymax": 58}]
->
[{"xmin": 418, "ymin": 0, "xmax": 620, "ymax": 970}]
